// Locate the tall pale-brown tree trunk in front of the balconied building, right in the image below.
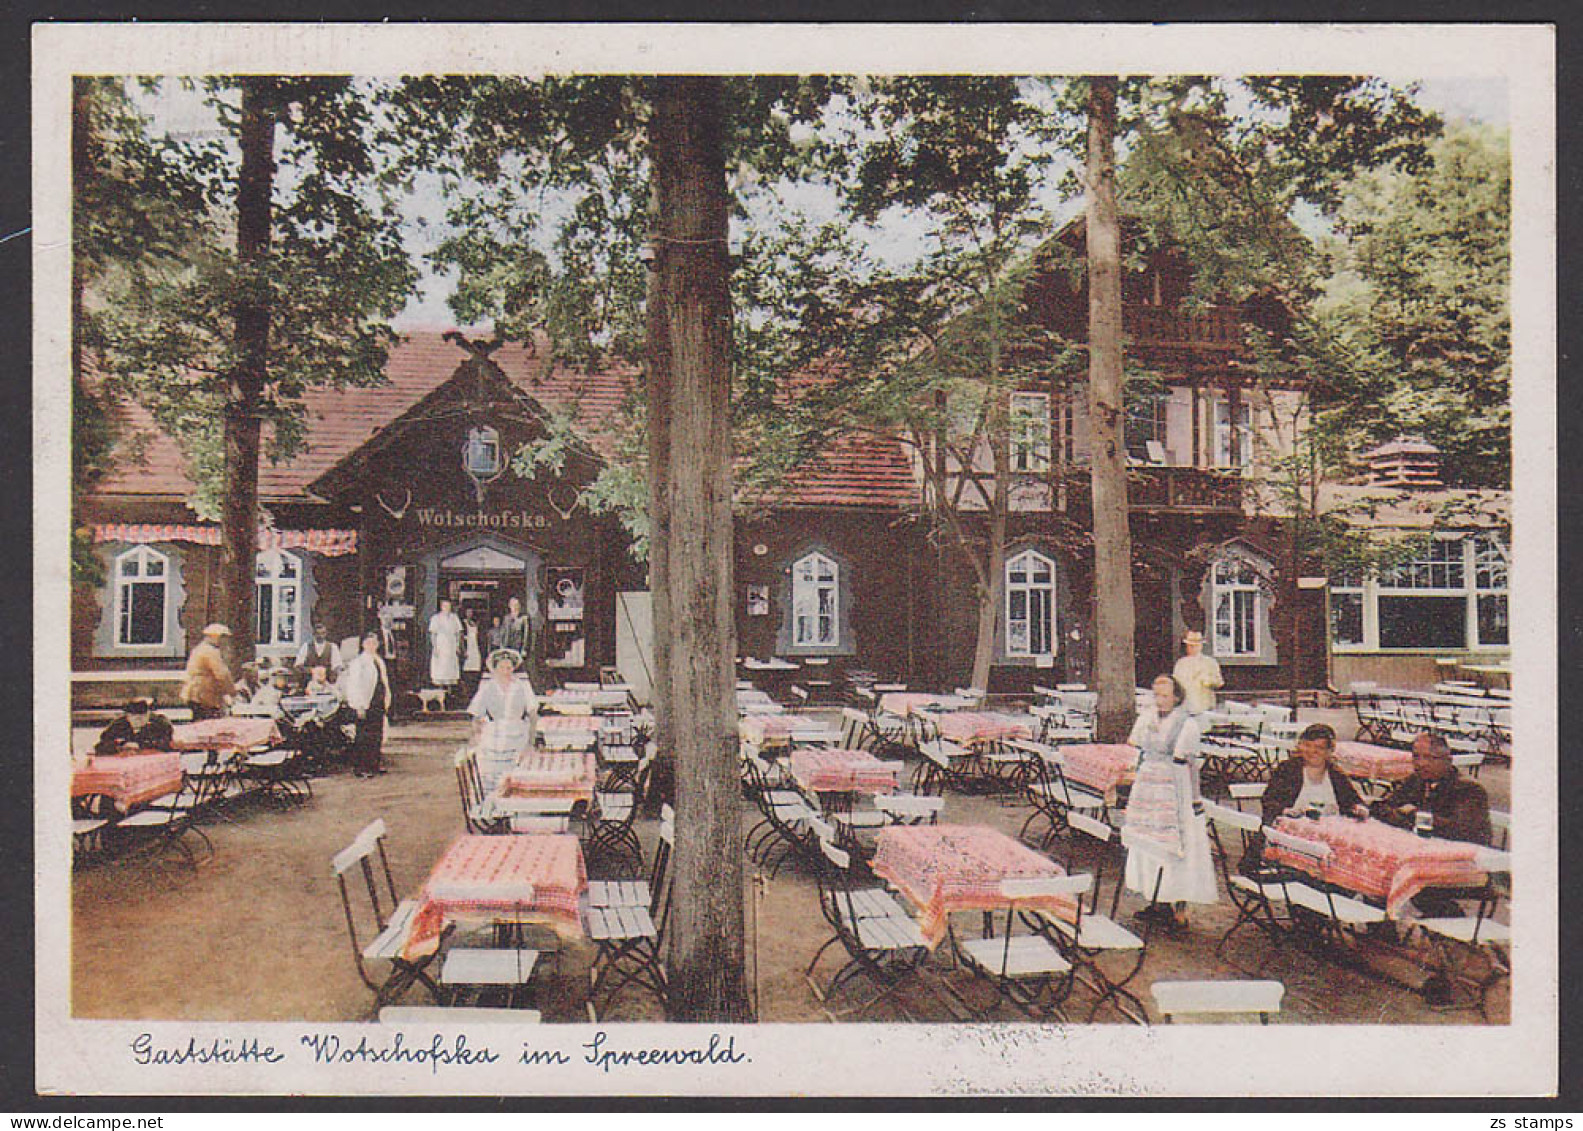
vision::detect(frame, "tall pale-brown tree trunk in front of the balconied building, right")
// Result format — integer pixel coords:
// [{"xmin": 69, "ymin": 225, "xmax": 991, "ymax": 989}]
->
[{"xmin": 1088, "ymin": 76, "xmax": 1138, "ymax": 743}]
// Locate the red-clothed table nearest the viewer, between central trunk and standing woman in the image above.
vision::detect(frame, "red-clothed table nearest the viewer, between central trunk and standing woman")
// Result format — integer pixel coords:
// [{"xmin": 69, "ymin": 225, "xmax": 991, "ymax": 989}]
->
[{"xmin": 872, "ymin": 825, "xmax": 1076, "ymax": 949}]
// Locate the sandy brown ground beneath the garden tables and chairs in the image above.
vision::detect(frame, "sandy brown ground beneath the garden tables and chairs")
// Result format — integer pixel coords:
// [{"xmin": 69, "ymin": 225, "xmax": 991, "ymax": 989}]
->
[{"xmin": 71, "ymin": 711, "xmax": 1510, "ymax": 1025}]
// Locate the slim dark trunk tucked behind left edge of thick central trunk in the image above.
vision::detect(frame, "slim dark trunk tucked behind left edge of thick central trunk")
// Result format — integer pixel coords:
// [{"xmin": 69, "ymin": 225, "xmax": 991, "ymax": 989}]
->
[{"xmin": 644, "ymin": 185, "xmax": 676, "ymax": 805}]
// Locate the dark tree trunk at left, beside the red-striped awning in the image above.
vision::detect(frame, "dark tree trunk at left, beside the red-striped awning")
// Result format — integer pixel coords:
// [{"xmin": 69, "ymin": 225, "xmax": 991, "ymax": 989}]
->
[{"xmin": 220, "ymin": 78, "xmax": 275, "ymax": 664}]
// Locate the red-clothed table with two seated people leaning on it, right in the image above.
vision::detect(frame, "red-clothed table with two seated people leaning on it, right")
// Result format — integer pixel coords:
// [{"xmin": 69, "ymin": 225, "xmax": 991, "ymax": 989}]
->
[{"xmin": 1265, "ymin": 817, "xmax": 1485, "ymax": 919}]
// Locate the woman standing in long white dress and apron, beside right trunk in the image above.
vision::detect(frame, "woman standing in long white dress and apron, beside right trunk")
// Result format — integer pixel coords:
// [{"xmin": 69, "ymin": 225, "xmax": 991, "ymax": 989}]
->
[{"xmin": 1121, "ymin": 675, "xmax": 1219, "ymax": 925}]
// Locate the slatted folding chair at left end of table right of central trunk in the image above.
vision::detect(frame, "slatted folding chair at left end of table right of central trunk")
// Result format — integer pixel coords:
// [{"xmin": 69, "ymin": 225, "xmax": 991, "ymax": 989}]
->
[{"xmin": 803, "ymin": 822, "xmax": 929, "ymax": 1020}]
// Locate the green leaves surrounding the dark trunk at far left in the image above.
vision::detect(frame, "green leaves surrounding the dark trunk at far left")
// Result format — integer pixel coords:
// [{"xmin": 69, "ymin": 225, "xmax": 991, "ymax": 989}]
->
[{"xmin": 76, "ymin": 78, "xmax": 416, "ymax": 516}]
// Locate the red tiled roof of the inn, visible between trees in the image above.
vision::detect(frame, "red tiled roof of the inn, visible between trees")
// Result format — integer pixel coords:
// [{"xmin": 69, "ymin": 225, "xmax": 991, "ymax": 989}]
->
[{"xmin": 95, "ymin": 329, "xmax": 918, "ymax": 507}]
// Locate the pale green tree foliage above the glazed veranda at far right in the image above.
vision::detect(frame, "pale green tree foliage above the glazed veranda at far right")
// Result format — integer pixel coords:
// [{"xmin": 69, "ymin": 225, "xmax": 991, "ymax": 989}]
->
[{"xmin": 1317, "ymin": 125, "xmax": 1512, "ymax": 488}]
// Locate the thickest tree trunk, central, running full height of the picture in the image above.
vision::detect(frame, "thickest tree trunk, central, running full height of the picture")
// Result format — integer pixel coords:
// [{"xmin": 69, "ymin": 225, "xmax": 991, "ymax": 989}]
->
[{"xmin": 651, "ymin": 76, "xmax": 752, "ymax": 1022}]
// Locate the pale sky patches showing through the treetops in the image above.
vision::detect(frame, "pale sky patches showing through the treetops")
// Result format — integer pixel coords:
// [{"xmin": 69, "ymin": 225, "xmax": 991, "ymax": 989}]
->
[{"xmin": 139, "ymin": 78, "xmax": 1509, "ymax": 329}]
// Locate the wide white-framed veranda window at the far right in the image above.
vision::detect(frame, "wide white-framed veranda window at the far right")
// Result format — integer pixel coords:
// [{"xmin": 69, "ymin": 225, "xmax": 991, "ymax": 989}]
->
[{"xmin": 1330, "ymin": 535, "xmax": 1510, "ymax": 651}]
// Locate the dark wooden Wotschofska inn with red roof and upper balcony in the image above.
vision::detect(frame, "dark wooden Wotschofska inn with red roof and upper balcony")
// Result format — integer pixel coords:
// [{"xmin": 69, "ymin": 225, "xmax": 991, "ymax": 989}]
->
[{"xmin": 71, "ymin": 225, "xmax": 1505, "ymax": 703}]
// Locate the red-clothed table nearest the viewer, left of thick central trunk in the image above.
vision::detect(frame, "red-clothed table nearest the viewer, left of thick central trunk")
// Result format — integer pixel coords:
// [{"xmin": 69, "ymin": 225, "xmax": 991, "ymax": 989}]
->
[{"xmin": 404, "ymin": 833, "xmax": 587, "ymax": 960}]
